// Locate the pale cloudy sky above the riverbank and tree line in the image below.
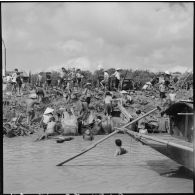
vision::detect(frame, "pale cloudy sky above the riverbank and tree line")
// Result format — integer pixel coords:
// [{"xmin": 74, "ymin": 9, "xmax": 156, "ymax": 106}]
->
[{"xmin": 2, "ymin": 2, "xmax": 194, "ymax": 72}]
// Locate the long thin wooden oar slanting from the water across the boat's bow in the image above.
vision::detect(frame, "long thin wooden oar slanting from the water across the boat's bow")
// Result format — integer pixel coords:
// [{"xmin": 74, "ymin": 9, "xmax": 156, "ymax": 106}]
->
[{"xmin": 56, "ymin": 107, "xmax": 160, "ymax": 166}]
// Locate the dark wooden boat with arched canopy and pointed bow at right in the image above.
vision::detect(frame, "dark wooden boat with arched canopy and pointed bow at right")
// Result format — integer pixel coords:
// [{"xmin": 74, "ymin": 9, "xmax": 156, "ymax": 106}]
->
[{"xmin": 119, "ymin": 102, "xmax": 194, "ymax": 171}]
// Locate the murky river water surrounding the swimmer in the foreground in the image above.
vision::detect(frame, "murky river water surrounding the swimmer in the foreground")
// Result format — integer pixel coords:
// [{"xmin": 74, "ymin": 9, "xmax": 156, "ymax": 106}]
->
[{"xmin": 3, "ymin": 134, "xmax": 193, "ymax": 193}]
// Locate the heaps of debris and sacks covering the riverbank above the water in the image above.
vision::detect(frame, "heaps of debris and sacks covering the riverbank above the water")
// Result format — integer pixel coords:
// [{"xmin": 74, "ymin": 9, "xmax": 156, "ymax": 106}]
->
[{"xmin": 3, "ymin": 70, "xmax": 193, "ymax": 137}]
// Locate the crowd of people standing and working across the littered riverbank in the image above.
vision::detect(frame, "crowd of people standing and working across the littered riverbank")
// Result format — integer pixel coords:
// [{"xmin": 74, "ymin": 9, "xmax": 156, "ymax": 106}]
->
[{"xmin": 2, "ymin": 67, "xmax": 192, "ymax": 139}]
